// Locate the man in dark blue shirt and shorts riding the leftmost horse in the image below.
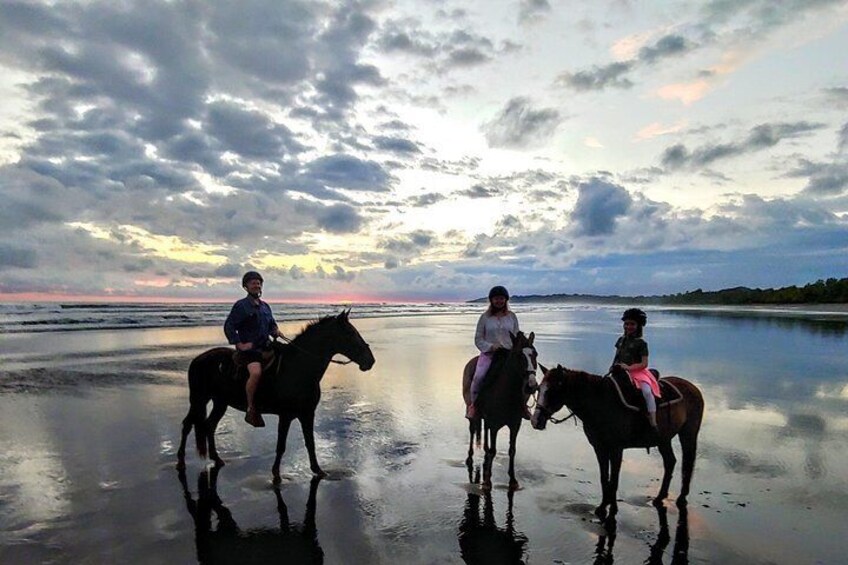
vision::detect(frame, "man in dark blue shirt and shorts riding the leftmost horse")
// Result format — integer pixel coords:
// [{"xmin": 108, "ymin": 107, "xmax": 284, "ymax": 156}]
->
[{"xmin": 224, "ymin": 271, "xmax": 283, "ymax": 428}]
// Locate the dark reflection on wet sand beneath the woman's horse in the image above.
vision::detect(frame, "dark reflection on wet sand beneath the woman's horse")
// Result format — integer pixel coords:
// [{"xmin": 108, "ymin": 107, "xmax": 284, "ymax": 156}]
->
[{"xmin": 457, "ymin": 466, "xmax": 528, "ymax": 565}]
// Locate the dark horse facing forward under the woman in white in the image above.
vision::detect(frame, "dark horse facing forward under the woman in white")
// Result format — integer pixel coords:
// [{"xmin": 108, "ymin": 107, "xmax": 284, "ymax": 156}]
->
[{"xmin": 462, "ymin": 332, "xmax": 536, "ymax": 489}]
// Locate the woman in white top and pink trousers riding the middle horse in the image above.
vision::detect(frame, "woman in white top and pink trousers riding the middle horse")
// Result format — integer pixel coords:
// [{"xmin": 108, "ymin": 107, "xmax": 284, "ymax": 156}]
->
[{"xmin": 465, "ymin": 286, "xmax": 519, "ymax": 420}]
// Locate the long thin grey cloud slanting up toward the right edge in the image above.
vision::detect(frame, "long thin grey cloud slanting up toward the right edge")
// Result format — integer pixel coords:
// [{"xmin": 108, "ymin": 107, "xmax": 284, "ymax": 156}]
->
[{"xmin": 660, "ymin": 122, "xmax": 825, "ymax": 170}]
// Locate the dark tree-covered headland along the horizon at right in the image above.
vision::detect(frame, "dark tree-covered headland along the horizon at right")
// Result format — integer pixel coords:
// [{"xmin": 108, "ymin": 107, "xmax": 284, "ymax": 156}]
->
[{"xmin": 476, "ymin": 278, "xmax": 848, "ymax": 305}]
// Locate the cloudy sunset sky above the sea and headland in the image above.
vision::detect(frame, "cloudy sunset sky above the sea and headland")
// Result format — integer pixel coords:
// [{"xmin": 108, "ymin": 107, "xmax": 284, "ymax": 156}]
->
[{"xmin": 0, "ymin": 0, "xmax": 848, "ymax": 301}]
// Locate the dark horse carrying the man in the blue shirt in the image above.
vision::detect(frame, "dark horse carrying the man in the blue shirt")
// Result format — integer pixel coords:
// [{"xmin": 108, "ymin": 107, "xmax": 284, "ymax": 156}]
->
[{"xmin": 177, "ymin": 311, "xmax": 374, "ymax": 483}]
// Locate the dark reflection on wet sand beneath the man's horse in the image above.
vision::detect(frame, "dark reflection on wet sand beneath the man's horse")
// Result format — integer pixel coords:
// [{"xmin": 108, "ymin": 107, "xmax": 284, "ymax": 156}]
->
[{"xmin": 179, "ymin": 467, "xmax": 324, "ymax": 565}]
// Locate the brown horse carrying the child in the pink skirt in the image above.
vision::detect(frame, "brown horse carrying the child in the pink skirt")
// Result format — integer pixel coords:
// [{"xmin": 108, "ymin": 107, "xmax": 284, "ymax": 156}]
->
[{"xmin": 531, "ymin": 365, "xmax": 704, "ymax": 518}]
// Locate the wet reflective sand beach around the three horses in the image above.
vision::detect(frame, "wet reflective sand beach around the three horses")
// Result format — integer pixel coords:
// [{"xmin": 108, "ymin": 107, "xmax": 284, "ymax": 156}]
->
[{"xmin": 0, "ymin": 307, "xmax": 848, "ymax": 564}]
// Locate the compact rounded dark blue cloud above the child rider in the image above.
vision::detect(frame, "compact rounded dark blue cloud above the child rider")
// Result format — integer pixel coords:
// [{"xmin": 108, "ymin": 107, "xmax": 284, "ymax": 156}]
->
[{"xmin": 571, "ymin": 179, "xmax": 633, "ymax": 236}]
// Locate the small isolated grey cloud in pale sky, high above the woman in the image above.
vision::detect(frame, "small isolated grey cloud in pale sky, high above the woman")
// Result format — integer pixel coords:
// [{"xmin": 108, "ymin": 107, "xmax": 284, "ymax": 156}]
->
[{"xmin": 483, "ymin": 97, "xmax": 562, "ymax": 148}]
